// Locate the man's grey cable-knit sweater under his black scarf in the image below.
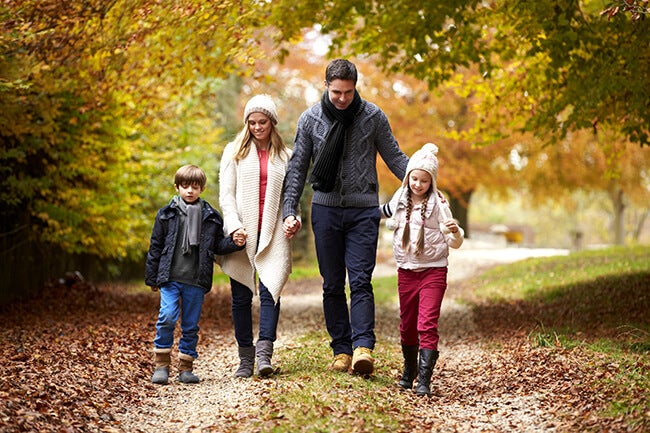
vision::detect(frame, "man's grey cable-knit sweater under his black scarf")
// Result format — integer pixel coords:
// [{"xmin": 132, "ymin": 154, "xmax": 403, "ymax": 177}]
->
[{"xmin": 282, "ymin": 100, "xmax": 408, "ymax": 219}]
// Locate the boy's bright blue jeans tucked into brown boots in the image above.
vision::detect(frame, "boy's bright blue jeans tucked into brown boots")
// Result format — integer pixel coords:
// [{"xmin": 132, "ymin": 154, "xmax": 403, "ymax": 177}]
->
[{"xmin": 153, "ymin": 281, "xmax": 205, "ymax": 358}]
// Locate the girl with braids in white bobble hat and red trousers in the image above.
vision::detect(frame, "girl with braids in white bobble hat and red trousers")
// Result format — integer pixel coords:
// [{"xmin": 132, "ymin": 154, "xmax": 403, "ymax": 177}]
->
[{"xmin": 381, "ymin": 143, "xmax": 464, "ymax": 396}]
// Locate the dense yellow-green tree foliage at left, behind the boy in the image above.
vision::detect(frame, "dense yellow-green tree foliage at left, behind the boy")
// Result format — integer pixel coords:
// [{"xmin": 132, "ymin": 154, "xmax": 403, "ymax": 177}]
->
[{"xmin": 0, "ymin": 0, "xmax": 264, "ymax": 298}]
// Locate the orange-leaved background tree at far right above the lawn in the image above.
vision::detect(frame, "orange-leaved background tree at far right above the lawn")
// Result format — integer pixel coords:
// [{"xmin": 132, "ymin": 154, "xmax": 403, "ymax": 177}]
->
[{"xmin": 510, "ymin": 131, "xmax": 650, "ymax": 245}]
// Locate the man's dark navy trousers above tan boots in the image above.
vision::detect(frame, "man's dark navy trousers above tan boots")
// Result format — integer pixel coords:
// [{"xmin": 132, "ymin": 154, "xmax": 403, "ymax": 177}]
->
[{"xmin": 311, "ymin": 204, "xmax": 380, "ymax": 355}]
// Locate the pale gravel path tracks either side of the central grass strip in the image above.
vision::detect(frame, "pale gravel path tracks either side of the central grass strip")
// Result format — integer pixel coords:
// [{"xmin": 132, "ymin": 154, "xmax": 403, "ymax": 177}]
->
[{"xmin": 118, "ymin": 243, "xmax": 564, "ymax": 433}]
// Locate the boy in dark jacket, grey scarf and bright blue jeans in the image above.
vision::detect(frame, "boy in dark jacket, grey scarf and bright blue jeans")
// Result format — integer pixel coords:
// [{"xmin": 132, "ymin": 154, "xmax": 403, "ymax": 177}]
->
[{"xmin": 145, "ymin": 165, "xmax": 246, "ymax": 384}]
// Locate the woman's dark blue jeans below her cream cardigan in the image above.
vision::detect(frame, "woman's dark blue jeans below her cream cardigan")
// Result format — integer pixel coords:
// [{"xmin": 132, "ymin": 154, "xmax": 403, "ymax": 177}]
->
[{"xmin": 230, "ymin": 278, "xmax": 280, "ymax": 347}]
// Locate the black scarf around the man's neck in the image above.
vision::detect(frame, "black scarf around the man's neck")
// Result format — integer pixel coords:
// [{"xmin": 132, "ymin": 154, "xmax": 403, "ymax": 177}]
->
[{"xmin": 309, "ymin": 89, "xmax": 361, "ymax": 192}]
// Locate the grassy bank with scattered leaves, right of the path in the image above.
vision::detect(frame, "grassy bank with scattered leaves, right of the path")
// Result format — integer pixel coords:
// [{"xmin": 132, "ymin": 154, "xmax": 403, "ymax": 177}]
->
[{"xmin": 473, "ymin": 246, "xmax": 650, "ymax": 427}]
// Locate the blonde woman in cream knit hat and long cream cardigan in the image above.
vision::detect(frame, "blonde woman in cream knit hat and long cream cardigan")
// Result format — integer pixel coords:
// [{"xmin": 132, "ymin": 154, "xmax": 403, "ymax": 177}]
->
[{"xmin": 219, "ymin": 95, "xmax": 291, "ymax": 377}]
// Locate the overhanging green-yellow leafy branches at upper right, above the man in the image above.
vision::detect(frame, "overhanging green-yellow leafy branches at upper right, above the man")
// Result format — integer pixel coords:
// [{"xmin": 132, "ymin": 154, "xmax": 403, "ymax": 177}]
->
[{"xmin": 269, "ymin": 0, "xmax": 650, "ymax": 145}]
